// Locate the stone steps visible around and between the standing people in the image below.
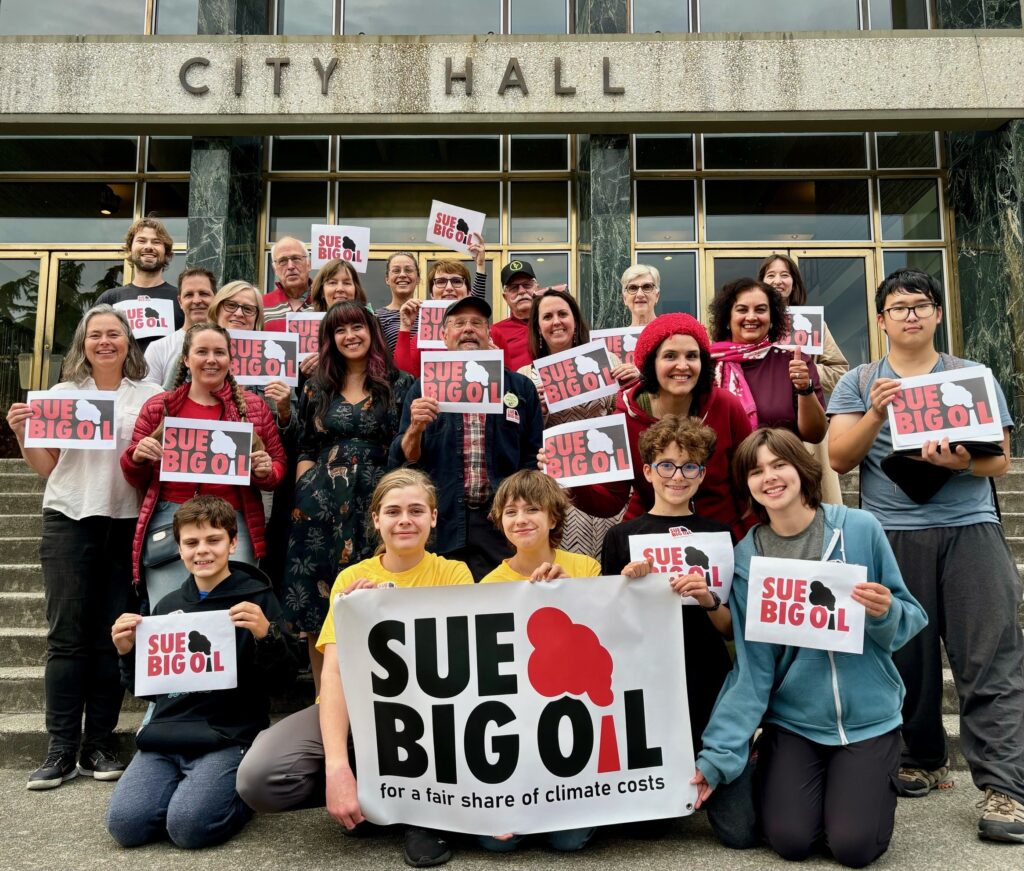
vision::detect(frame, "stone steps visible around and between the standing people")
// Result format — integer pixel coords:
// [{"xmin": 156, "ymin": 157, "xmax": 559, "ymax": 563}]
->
[{"xmin": 0, "ymin": 460, "xmax": 1024, "ymax": 770}]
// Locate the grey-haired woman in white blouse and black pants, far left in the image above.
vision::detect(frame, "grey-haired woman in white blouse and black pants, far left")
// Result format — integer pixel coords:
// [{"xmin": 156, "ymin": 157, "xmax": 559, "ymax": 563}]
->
[{"xmin": 7, "ymin": 305, "xmax": 161, "ymax": 789}]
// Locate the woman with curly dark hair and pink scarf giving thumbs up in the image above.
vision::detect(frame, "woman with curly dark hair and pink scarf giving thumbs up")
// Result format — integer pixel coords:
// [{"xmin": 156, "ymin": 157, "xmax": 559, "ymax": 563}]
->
[{"xmin": 711, "ymin": 278, "xmax": 828, "ymax": 444}]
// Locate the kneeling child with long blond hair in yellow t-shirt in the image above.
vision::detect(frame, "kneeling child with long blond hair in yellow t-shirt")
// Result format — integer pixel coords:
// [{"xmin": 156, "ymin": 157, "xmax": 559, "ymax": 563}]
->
[{"xmin": 237, "ymin": 469, "xmax": 473, "ymax": 868}]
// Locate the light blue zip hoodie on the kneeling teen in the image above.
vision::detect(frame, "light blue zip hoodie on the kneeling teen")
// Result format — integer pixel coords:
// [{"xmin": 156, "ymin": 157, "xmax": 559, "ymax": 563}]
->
[{"xmin": 696, "ymin": 505, "xmax": 928, "ymax": 787}]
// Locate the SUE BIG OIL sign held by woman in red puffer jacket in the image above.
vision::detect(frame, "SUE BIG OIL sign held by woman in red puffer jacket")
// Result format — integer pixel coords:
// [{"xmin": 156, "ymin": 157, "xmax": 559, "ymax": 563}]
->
[{"xmin": 160, "ymin": 418, "xmax": 253, "ymax": 485}]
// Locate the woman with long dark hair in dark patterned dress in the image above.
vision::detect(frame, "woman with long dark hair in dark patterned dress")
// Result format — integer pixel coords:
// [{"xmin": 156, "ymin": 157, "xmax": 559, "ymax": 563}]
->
[{"xmin": 284, "ymin": 302, "xmax": 413, "ymax": 687}]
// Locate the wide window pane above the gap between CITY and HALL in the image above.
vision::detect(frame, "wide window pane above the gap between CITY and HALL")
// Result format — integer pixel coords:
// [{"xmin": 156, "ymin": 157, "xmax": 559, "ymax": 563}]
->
[{"xmin": 342, "ymin": 0, "xmax": 502, "ymax": 36}]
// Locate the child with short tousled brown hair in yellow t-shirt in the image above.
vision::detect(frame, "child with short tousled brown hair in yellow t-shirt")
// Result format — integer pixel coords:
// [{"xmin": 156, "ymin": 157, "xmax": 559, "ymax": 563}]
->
[{"xmin": 480, "ymin": 469, "xmax": 601, "ymax": 583}]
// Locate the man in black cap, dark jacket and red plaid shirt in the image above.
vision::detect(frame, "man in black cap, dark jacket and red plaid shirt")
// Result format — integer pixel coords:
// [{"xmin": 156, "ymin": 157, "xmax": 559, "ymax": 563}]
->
[{"xmin": 390, "ymin": 296, "xmax": 543, "ymax": 580}]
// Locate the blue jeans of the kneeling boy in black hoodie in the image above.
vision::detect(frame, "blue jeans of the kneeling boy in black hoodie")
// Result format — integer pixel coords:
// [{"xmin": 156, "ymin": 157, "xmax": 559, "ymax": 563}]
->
[{"xmin": 106, "ymin": 747, "xmax": 253, "ymax": 850}]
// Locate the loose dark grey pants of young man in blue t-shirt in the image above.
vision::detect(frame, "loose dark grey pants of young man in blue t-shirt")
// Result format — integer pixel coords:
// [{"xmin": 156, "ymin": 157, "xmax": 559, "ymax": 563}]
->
[{"xmin": 886, "ymin": 523, "xmax": 1024, "ymax": 801}]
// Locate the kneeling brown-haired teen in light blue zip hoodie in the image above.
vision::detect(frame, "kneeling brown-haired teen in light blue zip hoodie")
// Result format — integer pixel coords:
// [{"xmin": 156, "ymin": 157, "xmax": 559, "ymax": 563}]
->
[{"xmin": 693, "ymin": 429, "xmax": 928, "ymax": 868}]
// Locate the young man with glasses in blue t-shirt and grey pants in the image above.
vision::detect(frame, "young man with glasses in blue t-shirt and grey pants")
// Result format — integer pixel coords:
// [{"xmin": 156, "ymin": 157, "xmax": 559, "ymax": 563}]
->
[{"xmin": 828, "ymin": 269, "xmax": 1024, "ymax": 843}]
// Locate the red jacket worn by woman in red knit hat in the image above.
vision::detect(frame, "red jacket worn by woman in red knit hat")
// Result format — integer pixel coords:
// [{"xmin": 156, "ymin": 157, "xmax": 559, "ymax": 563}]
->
[{"xmin": 572, "ymin": 384, "xmax": 755, "ymax": 541}]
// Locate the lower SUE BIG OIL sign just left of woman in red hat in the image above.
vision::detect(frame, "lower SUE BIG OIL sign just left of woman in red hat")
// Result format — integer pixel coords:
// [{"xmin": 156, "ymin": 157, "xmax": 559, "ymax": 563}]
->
[{"xmin": 544, "ymin": 415, "xmax": 633, "ymax": 487}]
